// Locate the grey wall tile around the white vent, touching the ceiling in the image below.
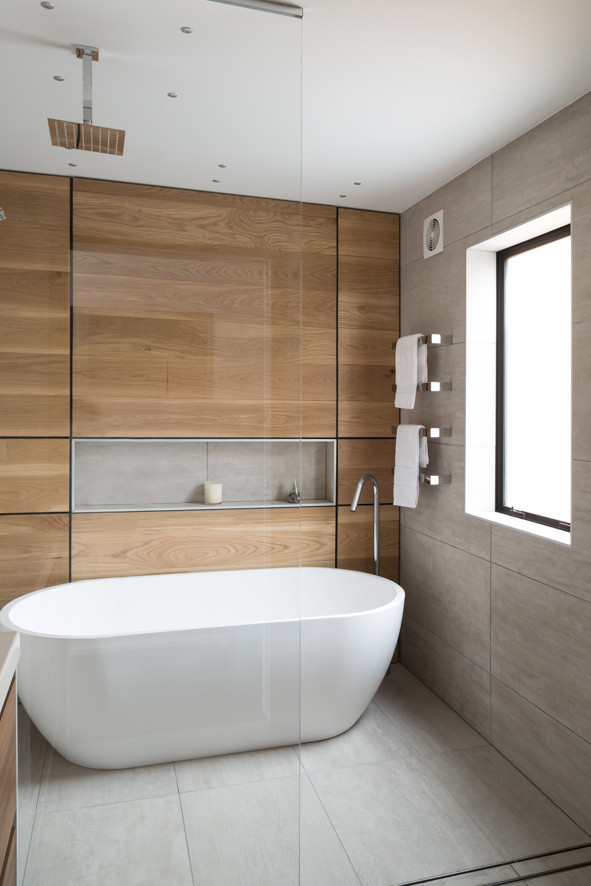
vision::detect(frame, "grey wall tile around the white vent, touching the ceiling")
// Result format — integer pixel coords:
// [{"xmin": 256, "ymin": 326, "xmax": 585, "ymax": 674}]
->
[{"xmin": 400, "ymin": 157, "xmax": 492, "ymax": 266}]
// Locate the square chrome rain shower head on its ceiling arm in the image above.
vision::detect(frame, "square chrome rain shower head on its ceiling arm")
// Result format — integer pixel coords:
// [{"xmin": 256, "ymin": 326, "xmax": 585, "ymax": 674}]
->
[{"xmin": 47, "ymin": 46, "xmax": 125, "ymax": 157}]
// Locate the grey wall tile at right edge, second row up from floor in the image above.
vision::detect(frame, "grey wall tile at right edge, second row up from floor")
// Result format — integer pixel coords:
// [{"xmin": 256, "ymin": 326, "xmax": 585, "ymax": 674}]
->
[{"xmin": 491, "ymin": 566, "xmax": 591, "ymax": 741}]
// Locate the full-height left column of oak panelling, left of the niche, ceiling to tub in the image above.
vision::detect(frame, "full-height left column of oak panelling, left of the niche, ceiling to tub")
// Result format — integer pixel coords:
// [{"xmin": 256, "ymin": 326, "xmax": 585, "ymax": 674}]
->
[{"xmin": 0, "ymin": 172, "xmax": 70, "ymax": 605}]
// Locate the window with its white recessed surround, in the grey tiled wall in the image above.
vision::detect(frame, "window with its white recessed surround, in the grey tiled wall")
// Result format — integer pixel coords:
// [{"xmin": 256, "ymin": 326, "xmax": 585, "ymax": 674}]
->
[{"xmin": 465, "ymin": 203, "xmax": 572, "ymax": 545}]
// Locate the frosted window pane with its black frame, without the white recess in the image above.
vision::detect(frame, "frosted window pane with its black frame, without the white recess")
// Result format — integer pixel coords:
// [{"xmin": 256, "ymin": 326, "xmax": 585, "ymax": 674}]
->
[{"xmin": 495, "ymin": 225, "xmax": 571, "ymax": 531}]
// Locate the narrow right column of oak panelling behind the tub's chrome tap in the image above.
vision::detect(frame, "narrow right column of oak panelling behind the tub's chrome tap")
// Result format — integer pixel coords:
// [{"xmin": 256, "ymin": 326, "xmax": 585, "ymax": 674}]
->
[{"xmin": 337, "ymin": 209, "xmax": 399, "ymax": 580}]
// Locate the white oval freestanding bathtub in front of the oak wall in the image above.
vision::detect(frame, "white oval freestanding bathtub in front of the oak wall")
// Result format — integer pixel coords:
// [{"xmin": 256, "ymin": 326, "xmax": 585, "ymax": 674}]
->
[{"xmin": 0, "ymin": 567, "xmax": 404, "ymax": 769}]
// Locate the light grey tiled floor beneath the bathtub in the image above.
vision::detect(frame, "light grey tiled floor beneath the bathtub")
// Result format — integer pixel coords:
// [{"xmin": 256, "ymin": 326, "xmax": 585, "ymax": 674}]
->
[{"xmin": 19, "ymin": 665, "xmax": 591, "ymax": 886}]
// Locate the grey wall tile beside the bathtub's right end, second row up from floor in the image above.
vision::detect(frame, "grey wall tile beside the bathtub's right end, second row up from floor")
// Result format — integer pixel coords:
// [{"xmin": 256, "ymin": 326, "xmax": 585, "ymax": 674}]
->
[{"xmin": 400, "ymin": 527, "xmax": 490, "ymax": 670}]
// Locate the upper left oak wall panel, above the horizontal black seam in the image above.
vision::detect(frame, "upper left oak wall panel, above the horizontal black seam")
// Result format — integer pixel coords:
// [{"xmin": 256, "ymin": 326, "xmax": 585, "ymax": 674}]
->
[{"xmin": 0, "ymin": 172, "xmax": 70, "ymax": 437}]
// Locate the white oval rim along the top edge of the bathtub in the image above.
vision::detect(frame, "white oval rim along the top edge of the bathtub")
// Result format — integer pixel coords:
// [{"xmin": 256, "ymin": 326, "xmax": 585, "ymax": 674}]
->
[{"xmin": 0, "ymin": 566, "xmax": 406, "ymax": 642}]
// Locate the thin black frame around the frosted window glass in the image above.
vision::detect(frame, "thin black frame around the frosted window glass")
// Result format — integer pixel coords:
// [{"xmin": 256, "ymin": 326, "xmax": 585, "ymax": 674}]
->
[{"xmin": 495, "ymin": 224, "xmax": 571, "ymax": 532}]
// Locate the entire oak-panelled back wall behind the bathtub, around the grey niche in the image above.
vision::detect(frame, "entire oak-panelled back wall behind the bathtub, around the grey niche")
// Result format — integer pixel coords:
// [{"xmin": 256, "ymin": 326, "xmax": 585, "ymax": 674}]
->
[{"xmin": 0, "ymin": 173, "xmax": 398, "ymax": 602}]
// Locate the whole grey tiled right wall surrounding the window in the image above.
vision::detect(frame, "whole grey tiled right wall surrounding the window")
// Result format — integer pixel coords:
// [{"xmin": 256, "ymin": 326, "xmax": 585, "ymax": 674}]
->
[{"xmin": 400, "ymin": 93, "xmax": 591, "ymax": 831}]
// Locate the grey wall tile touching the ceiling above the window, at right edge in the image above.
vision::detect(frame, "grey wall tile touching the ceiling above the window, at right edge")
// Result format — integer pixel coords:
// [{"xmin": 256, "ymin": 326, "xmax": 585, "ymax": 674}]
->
[{"xmin": 493, "ymin": 93, "xmax": 591, "ymax": 222}]
